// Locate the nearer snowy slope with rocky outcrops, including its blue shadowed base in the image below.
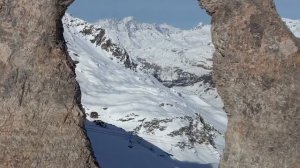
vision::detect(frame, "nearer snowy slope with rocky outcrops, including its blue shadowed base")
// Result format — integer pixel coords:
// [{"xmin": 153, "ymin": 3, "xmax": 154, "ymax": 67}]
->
[{"xmin": 64, "ymin": 16, "xmax": 227, "ymax": 168}]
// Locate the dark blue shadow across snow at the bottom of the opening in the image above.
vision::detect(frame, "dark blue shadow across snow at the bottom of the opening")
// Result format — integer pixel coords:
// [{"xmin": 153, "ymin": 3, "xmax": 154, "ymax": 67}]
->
[{"xmin": 85, "ymin": 121, "xmax": 213, "ymax": 168}]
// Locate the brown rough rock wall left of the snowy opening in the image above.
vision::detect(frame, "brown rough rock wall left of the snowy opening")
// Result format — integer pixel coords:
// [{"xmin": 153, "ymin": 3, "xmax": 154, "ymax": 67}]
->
[{"xmin": 0, "ymin": 0, "xmax": 97, "ymax": 168}]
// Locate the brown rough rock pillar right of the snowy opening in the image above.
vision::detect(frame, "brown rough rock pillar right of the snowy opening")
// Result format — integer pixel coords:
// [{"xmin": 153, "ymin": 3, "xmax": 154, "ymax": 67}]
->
[{"xmin": 200, "ymin": 0, "xmax": 300, "ymax": 168}]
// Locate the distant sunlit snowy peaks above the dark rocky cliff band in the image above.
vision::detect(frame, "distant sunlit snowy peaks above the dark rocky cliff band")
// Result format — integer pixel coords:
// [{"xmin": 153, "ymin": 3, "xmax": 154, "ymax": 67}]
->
[{"xmin": 96, "ymin": 17, "xmax": 214, "ymax": 78}]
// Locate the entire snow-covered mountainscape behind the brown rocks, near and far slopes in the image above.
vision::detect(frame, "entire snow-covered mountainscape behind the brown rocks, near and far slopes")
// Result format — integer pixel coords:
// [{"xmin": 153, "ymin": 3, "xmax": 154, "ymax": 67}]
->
[{"xmin": 63, "ymin": 14, "xmax": 300, "ymax": 168}]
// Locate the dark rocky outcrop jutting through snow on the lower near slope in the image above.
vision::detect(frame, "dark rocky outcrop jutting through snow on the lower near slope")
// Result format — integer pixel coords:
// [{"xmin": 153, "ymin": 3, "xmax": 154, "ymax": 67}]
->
[{"xmin": 130, "ymin": 113, "xmax": 221, "ymax": 149}]
